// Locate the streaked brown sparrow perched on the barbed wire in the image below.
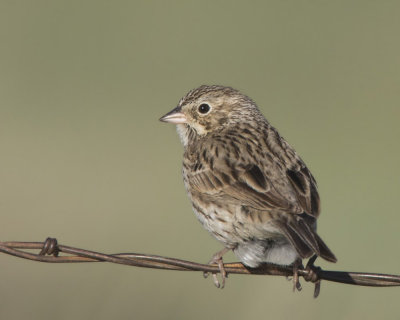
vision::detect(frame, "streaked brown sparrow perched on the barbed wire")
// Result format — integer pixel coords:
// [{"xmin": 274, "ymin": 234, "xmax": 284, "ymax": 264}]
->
[{"xmin": 160, "ymin": 85, "xmax": 337, "ymax": 290}]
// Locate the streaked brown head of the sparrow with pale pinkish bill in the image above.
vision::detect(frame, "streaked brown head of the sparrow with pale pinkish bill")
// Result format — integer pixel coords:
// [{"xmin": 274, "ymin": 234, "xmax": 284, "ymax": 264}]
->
[{"xmin": 160, "ymin": 85, "xmax": 260, "ymax": 145}]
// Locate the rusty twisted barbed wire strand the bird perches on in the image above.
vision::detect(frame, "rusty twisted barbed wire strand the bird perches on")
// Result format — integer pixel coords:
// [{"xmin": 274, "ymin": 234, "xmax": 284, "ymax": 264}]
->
[{"xmin": 0, "ymin": 238, "xmax": 400, "ymax": 297}]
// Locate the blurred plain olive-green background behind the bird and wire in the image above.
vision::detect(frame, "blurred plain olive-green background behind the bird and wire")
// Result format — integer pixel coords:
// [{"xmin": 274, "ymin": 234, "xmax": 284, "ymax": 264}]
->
[{"xmin": 0, "ymin": 0, "xmax": 400, "ymax": 320}]
